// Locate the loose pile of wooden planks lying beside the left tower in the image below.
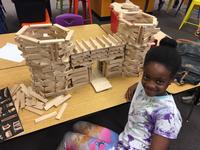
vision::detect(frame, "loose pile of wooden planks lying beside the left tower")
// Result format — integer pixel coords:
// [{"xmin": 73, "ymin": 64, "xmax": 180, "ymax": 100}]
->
[{"xmin": 10, "ymin": 84, "xmax": 71, "ymax": 123}]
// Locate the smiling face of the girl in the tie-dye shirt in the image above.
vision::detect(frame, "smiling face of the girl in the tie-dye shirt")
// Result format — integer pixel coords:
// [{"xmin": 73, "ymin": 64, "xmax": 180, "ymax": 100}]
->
[{"xmin": 142, "ymin": 62, "xmax": 172, "ymax": 96}]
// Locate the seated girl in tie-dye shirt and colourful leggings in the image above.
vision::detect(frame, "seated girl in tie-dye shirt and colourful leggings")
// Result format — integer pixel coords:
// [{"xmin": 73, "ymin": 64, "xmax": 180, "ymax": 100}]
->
[{"xmin": 58, "ymin": 38, "xmax": 182, "ymax": 150}]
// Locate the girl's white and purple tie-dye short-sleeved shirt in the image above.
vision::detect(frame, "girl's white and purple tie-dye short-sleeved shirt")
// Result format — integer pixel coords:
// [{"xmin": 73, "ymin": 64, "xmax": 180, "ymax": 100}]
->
[{"xmin": 115, "ymin": 82, "xmax": 182, "ymax": 150}]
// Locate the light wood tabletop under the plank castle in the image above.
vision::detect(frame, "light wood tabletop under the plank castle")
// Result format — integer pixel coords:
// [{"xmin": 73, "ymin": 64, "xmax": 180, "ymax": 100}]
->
[{"xmin": 0, "ymin": 24, "xmax": 139, "ymax": 139}]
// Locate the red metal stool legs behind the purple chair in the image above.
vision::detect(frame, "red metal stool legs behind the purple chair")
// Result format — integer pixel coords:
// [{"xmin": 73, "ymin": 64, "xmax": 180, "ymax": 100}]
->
[{"xmin": 69, "ymin": 0, "xmax": 92, "ymax": 24}]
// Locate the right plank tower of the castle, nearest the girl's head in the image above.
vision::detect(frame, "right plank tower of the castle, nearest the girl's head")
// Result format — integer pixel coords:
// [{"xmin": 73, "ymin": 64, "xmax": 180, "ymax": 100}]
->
[{"xmin": 112, "ymin": 4, "xmax": 160, "ymax": 76}]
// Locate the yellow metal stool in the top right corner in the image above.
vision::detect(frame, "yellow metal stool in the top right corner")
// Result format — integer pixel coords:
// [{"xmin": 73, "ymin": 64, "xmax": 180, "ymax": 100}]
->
[{"xmin": 179, "ymin": 0, "xmax": 200, "ymax": 30}]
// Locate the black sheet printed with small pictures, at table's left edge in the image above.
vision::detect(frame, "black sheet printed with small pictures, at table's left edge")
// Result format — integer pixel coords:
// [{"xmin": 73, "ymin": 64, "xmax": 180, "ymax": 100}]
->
[{"xmin": 0, "ymin": 88, "xmax": 24, "ymax": 142}]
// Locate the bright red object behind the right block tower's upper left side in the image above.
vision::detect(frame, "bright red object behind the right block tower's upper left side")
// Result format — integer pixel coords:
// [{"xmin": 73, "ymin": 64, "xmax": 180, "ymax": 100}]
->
[{"xmin": 111, "ymin": 9, "xmax": 119, "ymax": 33}]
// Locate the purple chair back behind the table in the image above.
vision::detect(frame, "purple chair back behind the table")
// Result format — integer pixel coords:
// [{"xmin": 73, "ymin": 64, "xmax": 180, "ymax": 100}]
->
[{"xmin": 54, "ymin": 13, "xmax": 83, "ymax": 27}]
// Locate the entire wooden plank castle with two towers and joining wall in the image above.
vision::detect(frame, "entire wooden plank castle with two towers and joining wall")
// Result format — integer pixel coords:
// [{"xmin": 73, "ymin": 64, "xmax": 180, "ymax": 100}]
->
[{"xmin": 16, "ymin": 2, "xmax": 160, "ymax": 98}]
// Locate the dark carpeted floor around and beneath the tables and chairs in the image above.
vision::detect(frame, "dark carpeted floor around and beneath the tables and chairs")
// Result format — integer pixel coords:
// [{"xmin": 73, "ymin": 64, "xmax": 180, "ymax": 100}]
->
[{"xmin": 0, "ymin": 0, "xmax": 200, "ymax": 150}]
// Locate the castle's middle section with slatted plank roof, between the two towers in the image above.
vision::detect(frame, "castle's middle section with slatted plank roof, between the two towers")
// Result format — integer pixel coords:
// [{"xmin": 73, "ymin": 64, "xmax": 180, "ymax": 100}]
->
[{"xmin": 70, "ymin": 35, "xmax": 125, "ymax": 78}]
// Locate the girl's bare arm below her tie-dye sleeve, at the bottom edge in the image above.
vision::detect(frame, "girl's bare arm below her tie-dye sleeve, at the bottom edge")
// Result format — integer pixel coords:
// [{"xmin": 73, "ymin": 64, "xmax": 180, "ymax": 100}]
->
[{"xmin": 150, "ymin": 134, "xmax": 170, "ymax": 150}]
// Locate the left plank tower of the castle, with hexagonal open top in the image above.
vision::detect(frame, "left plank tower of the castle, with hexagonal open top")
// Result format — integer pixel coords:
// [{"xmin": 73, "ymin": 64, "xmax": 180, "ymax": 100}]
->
[{"xmin": 16, "ymin": 24, "xmax": 74, "ymax": 97}]
